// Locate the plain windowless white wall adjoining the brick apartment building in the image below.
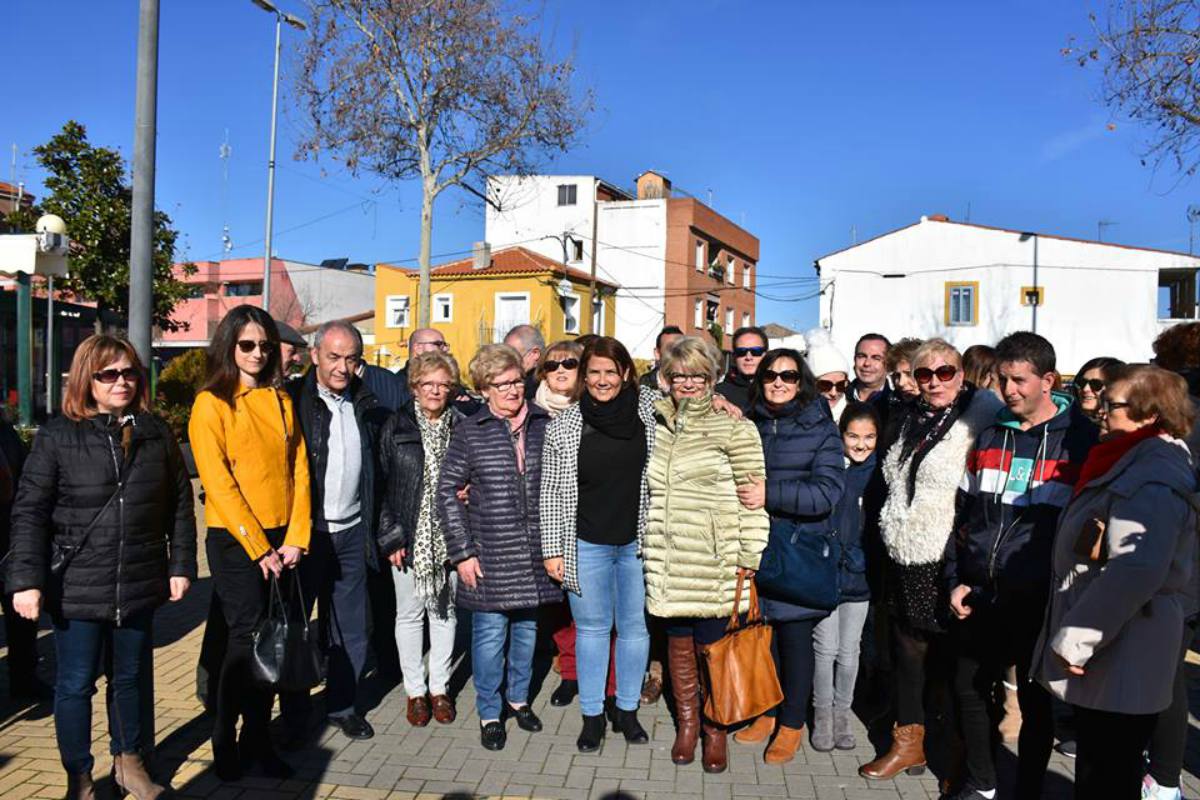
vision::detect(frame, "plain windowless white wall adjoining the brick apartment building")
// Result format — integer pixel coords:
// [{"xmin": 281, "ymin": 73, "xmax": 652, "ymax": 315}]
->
[{"xmin": 596, "ymin": 199, "xmax": 667, "ymax": 359}]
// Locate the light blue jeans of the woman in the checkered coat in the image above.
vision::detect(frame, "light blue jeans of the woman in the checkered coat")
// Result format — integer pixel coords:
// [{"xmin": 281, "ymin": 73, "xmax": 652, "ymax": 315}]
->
[{"xmin": 568, "ymin": 540, "xmax": 650, "ymax": 716}]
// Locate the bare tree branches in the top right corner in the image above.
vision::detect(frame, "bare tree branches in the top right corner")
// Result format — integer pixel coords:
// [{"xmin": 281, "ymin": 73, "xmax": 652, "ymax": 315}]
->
[{"xmin": 1063, "ymin": 0, "xmax": 1200, "ymax": 175}]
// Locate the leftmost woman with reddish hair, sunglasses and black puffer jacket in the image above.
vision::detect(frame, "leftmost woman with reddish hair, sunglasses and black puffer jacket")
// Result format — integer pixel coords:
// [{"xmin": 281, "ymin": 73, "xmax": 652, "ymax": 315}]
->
[{"xmin": 6, "ymin": 336, "xmax": 196, "ymax": 798}]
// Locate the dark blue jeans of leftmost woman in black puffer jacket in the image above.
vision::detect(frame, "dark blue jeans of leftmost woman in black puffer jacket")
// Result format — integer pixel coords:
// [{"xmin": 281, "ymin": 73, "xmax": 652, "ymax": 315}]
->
[{"xmin": 54, "ymin": 612, "xmax": 154, "ymax": 775}]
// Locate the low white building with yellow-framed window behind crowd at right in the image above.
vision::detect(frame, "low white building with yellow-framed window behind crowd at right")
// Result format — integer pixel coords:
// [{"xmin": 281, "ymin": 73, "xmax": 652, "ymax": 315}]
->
[{"xmin": 815, "ymin": 215, "xmax": 1200, "ymax": 374}]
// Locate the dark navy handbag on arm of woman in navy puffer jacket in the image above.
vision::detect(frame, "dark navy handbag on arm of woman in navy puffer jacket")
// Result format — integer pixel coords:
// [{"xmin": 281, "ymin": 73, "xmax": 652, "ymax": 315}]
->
[{"xmin": 755, "ymin": 530, "xmax": 841, "ymax": 610}]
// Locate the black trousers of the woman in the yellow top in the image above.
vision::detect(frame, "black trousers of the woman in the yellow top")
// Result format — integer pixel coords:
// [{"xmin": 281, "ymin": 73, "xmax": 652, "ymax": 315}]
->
[{"xmin": 204, "ymin": 528, "xmax": 286, "ymax": 752}]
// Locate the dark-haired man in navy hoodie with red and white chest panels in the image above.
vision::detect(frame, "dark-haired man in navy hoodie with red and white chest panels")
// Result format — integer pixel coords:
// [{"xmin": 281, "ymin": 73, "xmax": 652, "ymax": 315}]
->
[{"xmin": 944, "ymin": 332, "xmax": 1097, "ymax": 800}]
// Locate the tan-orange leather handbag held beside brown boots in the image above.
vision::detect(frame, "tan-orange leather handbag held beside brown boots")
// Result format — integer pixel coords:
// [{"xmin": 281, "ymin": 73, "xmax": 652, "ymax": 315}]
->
[{"xmin": 701, "ymin": 576, "xmax": 784, "ymax": 724}]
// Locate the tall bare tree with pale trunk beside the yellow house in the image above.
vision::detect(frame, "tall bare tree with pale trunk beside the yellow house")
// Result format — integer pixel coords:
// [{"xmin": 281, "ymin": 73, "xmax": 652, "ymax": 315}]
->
[{"xmin": 298, "ymin": 0, "xmax": 593, "ymax": 326}]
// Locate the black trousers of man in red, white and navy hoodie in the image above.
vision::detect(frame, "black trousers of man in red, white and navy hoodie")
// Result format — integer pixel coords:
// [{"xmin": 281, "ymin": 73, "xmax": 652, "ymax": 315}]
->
[{"xmin": 952, "ymin": 608, "xmax": 1054, "ymax": 798}]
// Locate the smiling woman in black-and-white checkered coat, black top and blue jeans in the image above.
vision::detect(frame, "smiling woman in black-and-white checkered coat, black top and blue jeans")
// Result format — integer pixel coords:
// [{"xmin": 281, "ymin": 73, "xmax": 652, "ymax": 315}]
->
[{"xmin": 541, "ymin": 337, "xmax": 659, "ymax": 753}]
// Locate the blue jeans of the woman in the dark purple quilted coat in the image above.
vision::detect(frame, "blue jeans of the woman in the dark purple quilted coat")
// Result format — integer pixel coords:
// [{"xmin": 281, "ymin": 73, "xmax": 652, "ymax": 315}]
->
[{"xmin": 470, "ymin": 607, "xmax": 538, "ymax": 722}]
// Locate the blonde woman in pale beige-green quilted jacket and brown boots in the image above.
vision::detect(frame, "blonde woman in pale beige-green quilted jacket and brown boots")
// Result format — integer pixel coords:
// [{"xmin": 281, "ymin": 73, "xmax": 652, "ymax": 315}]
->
[{"xmin": 644, "ymin": 337, "xmax": 770, "ymax": 772}]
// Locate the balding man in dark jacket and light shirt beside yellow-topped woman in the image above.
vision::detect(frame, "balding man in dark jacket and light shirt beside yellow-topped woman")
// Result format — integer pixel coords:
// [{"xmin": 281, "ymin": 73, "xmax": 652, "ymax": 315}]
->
[{"xmin": 282, "ymin": 320, "xmax": 386, "ymax": 739}]
